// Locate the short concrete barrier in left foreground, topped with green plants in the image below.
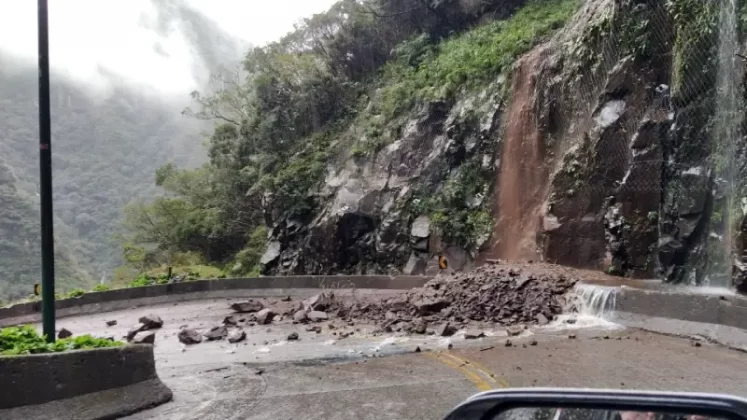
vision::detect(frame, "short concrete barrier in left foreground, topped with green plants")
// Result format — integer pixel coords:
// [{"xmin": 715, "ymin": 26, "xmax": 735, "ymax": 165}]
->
[{"xmin": 0, "ymin": 345, "xmax": 172, "ymax": 420}]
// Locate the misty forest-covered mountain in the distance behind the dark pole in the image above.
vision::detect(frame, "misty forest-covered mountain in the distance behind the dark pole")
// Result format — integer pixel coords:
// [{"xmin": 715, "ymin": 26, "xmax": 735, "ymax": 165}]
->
[{"xmin": 0, "ymin": 0, "xmax": 247, "ymax": 300}]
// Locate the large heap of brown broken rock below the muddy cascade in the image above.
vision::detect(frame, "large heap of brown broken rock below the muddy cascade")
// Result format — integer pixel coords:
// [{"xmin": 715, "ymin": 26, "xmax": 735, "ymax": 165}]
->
[{"xmin": 332, "ymin": 264, "xmax": 576, "ymax": 335}]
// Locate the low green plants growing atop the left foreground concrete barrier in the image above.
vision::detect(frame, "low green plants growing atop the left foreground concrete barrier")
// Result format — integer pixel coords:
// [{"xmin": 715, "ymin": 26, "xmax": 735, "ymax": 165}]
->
[{"xmin": 0, "ymin": 325, "xmax": 124, "ymax": 356}]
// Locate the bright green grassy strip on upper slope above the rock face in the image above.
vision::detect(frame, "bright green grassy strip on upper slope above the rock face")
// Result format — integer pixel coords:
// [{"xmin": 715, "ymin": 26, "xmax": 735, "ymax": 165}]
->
[{"xmin": 354, "ymin": 0, "xmax": 579, "ymax": 154}]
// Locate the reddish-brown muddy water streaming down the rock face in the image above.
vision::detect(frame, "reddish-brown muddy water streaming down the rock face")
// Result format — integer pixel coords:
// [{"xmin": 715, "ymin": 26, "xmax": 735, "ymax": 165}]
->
[{"xmin": 491, "ymin": 48, "xmax": 548, "ymax": 261}]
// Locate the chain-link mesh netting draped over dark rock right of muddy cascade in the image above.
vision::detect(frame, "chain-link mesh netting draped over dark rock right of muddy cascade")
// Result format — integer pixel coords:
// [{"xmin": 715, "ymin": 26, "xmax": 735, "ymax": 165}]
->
[{"xmin": 544, "ymin": 0, "xmax": 745, "ymax": 285}]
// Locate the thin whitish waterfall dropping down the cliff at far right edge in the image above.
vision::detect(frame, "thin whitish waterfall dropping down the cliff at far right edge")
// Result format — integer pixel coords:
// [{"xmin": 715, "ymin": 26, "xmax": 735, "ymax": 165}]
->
[{"xmin": 708, "ymin": 0, "xmax": 744, "ymax": 287}]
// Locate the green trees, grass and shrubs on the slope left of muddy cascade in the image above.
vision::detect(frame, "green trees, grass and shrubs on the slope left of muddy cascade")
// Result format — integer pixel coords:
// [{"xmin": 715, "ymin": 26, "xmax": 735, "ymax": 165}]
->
[{"xmin": 117, "ymin": 0, "xmax": 579, "ymax": 276}]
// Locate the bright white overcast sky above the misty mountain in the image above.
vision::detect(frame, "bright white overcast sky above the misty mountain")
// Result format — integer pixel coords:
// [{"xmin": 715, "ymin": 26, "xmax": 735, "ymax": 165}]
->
[{"xmin": 0, "ymin": 0, "xmax": 335, "ymax": 94}]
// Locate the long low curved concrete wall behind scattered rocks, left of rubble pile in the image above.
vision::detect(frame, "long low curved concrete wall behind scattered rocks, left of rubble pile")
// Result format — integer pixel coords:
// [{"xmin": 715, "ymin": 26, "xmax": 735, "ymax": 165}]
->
[{"xmin": 0, "ymin": 276, "xmax": 431, "ymax": 327}]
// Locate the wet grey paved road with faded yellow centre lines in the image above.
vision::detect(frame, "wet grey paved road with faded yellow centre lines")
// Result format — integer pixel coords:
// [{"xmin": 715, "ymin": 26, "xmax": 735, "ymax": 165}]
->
[{"xmin": 48, "ymin": 300, "xmax": 747, "ymax": 419}]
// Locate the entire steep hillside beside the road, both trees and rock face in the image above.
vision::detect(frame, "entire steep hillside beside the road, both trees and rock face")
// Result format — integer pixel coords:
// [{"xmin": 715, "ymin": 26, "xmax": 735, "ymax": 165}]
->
[{"xmin": 127, "ymin": 0, "xmax": 745, "ymax": 285}]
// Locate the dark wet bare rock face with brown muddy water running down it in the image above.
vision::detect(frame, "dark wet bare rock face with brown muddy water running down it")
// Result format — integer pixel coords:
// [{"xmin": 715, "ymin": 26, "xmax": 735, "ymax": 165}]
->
[{"xmin": 262, "ymin": 0, "xmax": 747, "ymax": 284}]
